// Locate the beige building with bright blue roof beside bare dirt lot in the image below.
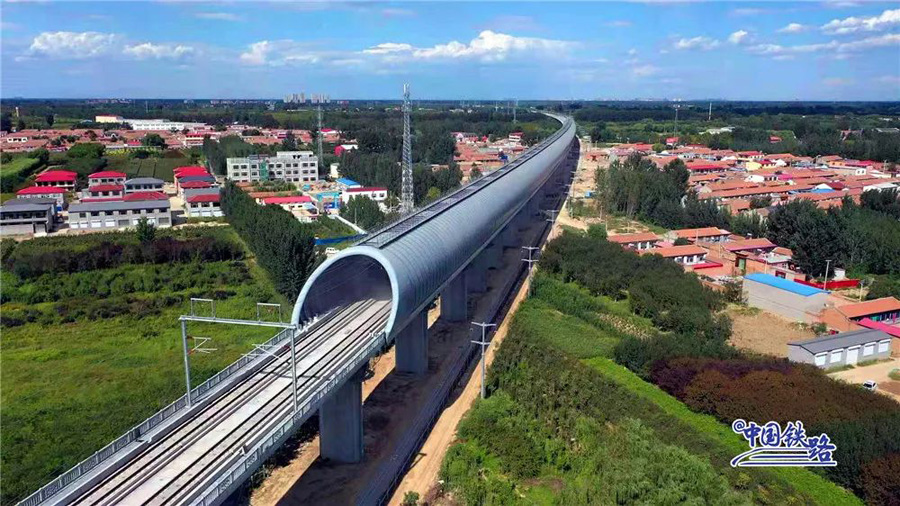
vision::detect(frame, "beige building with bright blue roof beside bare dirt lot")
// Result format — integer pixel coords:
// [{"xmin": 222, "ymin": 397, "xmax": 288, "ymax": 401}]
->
[{"xmin": 743, "ymin": 272, "xmax": 828, "ymax": 323}]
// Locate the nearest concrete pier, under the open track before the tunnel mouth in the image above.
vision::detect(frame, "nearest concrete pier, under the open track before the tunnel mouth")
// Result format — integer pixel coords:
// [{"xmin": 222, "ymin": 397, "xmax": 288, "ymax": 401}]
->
[{"xmin": 319, "ymin": 367, "xmax": 365, "ymax": 464}]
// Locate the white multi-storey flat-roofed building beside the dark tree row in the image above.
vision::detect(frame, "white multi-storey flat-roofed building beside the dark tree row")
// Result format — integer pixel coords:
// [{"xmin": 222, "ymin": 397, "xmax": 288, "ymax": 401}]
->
[{"xmin": 226, "ymin": 151, "xmax": 319, "ymax": 183}]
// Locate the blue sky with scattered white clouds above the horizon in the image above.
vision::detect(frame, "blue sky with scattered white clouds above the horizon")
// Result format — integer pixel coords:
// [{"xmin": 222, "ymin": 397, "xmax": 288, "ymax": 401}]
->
[{"xmin": 0, "ymin": 0, "xmax": 900, "ymax": 100}]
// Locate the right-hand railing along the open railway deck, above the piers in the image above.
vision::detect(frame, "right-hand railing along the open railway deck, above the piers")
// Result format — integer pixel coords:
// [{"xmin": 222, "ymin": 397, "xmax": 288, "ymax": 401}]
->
[{"xmin": 194, "ymin": 332, "xmax": 386, "ymax": 506}]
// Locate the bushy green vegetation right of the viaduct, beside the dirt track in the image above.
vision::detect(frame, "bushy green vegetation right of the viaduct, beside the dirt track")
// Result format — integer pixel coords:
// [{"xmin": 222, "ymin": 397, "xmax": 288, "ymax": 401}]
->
[{"xmin": 442, "ymin": 275, "xmax": 861, "ymax": 505}]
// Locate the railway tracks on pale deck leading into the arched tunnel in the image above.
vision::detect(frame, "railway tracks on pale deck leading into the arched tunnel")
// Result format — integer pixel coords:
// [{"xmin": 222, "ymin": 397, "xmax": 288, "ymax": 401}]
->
[{"xmin": 69, "ymin": 300, "xmax": 390, "ymax": 505}]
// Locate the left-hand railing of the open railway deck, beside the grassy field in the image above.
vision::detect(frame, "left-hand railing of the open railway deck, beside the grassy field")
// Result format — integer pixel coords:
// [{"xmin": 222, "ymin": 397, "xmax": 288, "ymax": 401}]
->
[{"xmin": 19, "ymin": 329, "xmax": 290, "ymax": 506}]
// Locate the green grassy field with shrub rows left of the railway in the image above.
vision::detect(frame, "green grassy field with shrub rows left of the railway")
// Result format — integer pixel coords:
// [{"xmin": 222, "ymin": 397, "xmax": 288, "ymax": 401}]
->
[{"xmin": 0, "ymin": 227, "xmax": 289, "ymax": 504}]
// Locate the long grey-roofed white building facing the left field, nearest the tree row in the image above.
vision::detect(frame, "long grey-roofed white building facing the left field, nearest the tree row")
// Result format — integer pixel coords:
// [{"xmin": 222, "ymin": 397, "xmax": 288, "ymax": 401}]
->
[{"xmin": 69, "ymin": 200, "xmax": 172, "ymax": 230}]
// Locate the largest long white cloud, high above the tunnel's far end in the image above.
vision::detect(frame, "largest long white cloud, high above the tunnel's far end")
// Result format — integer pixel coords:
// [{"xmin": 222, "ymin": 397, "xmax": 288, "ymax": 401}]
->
[{"xmin": 363, "ymin": 30, "xmax": 573, "ymax": 62}]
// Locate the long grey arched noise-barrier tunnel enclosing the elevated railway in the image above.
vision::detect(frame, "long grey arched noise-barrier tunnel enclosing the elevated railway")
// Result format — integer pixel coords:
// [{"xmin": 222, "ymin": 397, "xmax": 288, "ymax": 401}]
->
[{"xmin": 292, "ymin": 112, "xmax": 575, "ymax": 338}]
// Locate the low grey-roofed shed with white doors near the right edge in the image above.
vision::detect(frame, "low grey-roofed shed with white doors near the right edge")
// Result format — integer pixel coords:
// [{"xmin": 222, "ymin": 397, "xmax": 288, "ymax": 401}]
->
[{"xmin": 788, "ymin": 329, "xmax": 891, "ymax": 369}]
